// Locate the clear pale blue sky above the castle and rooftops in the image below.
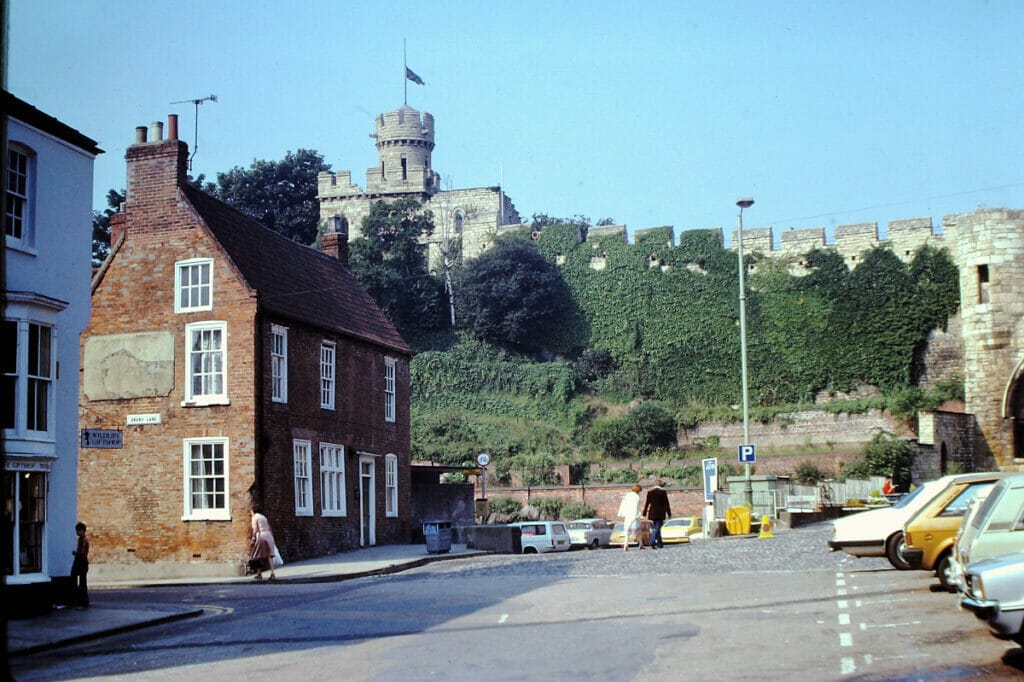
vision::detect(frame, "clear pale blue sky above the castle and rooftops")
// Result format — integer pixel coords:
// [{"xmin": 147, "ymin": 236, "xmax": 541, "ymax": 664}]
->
[{"xmin": 7, "ymin": 0, "xmax": 1024, "ymax": 240}]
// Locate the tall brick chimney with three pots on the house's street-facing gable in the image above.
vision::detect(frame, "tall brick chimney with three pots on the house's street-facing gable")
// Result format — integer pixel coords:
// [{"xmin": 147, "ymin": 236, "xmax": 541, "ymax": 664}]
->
[{"xmin": 125, "ymin": 114, "xmax": 188, "ymax": 213}]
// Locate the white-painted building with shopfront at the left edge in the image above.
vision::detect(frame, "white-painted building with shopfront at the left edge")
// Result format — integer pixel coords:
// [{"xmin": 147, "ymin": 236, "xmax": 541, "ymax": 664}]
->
[{"xmin": 0, "ymin": 92, "xmax": 102, "ymax": 607}]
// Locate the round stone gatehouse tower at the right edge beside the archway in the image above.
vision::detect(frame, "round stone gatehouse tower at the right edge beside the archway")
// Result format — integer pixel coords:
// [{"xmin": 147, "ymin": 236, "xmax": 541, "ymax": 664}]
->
[{"xmin": 943, "ymin": 209, "xmax": 1024, "ymax": 470}]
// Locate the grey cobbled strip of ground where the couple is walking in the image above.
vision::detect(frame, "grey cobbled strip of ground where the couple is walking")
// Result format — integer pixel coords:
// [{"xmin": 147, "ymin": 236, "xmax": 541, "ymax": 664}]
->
[{"xmin": 417, "ymin": 522, "xmax": 892, "ymax": 579}]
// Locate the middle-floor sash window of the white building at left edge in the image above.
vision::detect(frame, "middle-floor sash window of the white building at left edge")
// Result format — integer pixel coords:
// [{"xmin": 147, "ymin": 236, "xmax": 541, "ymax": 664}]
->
[{"xmin": 0, "ymin": 319, "xmax": 56, "ymax": 434}]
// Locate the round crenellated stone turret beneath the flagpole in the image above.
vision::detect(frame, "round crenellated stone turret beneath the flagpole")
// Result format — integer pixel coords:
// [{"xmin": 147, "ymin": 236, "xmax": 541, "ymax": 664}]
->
[{"xmin": 367, "ymin": 104, "xmax": 438, "ymax": 199}]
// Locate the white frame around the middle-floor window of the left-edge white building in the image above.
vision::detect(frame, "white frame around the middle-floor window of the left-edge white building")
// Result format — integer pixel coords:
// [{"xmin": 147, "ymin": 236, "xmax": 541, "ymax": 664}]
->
[{"xmin": 3, "ymin": 311, "xmax": 57, "ymax": 438}]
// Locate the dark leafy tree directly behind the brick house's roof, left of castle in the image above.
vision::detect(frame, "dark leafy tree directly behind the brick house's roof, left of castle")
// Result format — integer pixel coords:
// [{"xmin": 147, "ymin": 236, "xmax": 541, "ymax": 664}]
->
[{"xmin": 207, "ymin": 150, "xmax": 331, "ymax": 245}]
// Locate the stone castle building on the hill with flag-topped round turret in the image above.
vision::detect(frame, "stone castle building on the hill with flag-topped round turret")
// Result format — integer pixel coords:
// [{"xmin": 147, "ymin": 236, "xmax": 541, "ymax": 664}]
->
[{"xmin": 317, "ymin": 104, "xmax": 520, "ymax": 264}]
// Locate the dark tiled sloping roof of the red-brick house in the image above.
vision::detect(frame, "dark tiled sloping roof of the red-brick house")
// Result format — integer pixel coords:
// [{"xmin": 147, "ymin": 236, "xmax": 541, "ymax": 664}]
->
[{"xmin": 184, "ymin": 186, "xmax": 412, "ymax": 353}]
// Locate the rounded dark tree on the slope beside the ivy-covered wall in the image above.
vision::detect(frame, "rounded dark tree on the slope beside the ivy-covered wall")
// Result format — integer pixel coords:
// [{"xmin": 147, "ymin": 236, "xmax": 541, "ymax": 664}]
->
[{"xmin": 456, "ymin": 238, "xmax": 573, "ymax": 352}]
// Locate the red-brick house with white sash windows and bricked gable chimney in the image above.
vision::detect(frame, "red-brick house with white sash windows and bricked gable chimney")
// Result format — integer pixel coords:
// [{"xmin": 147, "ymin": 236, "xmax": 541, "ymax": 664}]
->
[{"xmin": 79, "ymin": 115, "xmax": 412, "ymax": 577}]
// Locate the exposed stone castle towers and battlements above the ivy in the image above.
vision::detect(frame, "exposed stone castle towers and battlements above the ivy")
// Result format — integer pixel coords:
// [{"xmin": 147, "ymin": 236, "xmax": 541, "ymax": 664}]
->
[{"xmin": 318, "ymin": 105, "xmax": 1024, "ymax": 471}]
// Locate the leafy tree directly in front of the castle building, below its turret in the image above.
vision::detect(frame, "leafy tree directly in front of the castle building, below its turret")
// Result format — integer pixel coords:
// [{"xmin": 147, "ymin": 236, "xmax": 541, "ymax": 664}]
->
[{"xmin": 349, "ymin": 199, "xmax": 444, "ymax": 343}]
